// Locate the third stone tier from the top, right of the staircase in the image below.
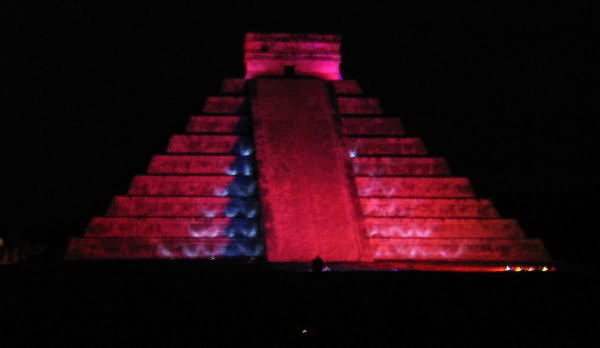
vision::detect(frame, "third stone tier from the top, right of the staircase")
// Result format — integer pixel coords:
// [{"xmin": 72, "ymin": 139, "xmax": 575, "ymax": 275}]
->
[{"xmin": 342, "ymin": 117, "xmax": 404, "ymax": 136}]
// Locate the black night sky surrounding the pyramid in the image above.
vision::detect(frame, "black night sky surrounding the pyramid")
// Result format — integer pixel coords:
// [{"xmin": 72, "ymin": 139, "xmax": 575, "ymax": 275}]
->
[{"xmin": 9, "ymin": 1, "xmax": 599, "ymax": 263}]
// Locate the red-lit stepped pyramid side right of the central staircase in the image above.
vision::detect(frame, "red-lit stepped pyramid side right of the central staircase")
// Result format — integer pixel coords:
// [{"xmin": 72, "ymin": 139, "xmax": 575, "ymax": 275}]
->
[{"xmin": 332, "ymin": 82, "xmax": 550, "ymax": 270}]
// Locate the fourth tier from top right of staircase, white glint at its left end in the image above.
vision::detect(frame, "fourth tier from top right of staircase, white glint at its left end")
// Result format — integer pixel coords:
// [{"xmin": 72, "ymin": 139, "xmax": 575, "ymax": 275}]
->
[{"xmin": 344, "ymin": 137, "xmax": 427, "ymax": 157}]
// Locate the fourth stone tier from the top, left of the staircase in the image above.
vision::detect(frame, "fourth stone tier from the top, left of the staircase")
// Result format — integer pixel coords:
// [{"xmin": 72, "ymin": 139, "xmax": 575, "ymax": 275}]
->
[{"xmin": 167, "ymin": 134, "xmax": 254, "ymax": 156}]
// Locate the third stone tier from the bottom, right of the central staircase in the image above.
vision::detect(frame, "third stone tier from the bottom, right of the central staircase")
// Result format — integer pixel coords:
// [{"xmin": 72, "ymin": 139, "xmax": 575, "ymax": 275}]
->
[{"xmin": 360, "ymin": 198, "xmax": 498, "ymax": 218}]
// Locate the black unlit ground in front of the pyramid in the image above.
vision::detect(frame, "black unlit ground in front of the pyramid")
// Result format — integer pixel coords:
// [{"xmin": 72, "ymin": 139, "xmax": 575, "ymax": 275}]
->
[{"xmin": 0, "ymin": 262, "xmax": 599, "ymax": 347}]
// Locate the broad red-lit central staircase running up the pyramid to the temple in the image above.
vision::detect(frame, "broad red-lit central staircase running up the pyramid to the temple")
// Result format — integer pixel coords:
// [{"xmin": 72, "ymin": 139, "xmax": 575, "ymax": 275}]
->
[{"xmin": 252, "ymin": 79, "xmax": 361, "ymax": 262}]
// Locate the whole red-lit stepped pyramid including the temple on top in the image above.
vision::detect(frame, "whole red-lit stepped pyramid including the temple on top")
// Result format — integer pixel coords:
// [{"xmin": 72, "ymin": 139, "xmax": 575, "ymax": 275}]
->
[{"xmin": 67, "ymin": 33, "xmax": 551, "ymax": 271}]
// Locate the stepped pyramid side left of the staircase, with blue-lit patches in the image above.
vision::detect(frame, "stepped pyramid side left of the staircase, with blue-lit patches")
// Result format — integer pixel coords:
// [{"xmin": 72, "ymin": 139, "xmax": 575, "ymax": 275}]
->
[{"xmin": 67, "ymin": 89, "xmax": 264, "ymax": 259}]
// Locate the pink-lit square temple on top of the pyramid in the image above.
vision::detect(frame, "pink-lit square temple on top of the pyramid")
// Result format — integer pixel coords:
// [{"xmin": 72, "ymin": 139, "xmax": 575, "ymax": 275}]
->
[{"xmin": 244, "ymin": 33, "xmax": 342, "ymax": 80}]
